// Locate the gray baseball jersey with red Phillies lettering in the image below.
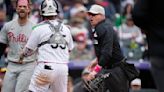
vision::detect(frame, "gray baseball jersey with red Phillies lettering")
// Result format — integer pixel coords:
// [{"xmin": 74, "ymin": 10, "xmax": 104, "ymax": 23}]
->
[{"xmin": 0, "ymin": 19, "xmax": 35, "ymax": 62}]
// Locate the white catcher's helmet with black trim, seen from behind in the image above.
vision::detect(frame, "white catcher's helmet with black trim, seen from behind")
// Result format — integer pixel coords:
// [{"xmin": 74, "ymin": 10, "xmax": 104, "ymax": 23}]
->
[{"xmin": 40, "ymin": 0, "xmax": 59, "ymax": 16}]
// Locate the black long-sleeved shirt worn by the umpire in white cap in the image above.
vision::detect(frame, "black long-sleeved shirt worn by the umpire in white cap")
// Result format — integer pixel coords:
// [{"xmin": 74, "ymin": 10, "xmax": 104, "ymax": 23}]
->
[{"xmin": 92, "ymin": 19, "xmax": 124, "ymax": 68}]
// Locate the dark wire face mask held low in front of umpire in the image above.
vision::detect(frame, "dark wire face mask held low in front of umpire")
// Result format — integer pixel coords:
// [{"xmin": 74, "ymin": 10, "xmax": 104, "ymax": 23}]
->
[{"xmin": 83, "ymin": 73, "xmax": 110, "ymax": 92}]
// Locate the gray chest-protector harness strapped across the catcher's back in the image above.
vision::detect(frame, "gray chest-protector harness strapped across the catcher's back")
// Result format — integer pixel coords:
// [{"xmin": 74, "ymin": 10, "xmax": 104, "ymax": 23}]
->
[{"xmin": 38, "ymin": 21, "xmax": 67, "ymax": 49}]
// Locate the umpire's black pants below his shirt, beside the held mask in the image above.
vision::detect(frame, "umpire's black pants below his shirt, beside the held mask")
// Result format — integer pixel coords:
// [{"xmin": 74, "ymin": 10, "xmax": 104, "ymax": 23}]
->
[{"xmin": 101, "ymin": 66, "xmax": 129, "ymax": 92}]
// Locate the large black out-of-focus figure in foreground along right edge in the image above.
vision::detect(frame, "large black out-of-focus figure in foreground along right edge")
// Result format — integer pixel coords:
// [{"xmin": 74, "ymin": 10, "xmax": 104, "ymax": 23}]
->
[{"xmin": 133, "ymin": 0, "xmax": 164, "ymax": 92}]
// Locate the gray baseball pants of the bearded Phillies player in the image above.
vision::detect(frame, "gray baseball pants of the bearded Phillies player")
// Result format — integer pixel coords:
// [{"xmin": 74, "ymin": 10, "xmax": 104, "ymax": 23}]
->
[{"xmin": 1, "ymin": 62, "xmax": 36, "ymax": 92}]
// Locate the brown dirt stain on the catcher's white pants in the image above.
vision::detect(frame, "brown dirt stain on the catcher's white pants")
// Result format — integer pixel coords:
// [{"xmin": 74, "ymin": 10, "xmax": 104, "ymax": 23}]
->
[{"xmin": 35, "ymin": 73, "xmax": 51, "ymax": 86}]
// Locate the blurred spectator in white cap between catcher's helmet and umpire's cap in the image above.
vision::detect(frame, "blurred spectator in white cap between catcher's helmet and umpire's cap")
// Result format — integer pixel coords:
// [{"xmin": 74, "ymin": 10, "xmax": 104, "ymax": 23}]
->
[{"xmin": 69, "ymin": 2, "xmax": 88, "ymax": 36}]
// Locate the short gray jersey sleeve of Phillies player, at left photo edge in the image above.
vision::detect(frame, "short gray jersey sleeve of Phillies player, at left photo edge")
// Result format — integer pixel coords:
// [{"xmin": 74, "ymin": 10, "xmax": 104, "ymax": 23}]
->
[{"xmin": 0, "ymin": 24, "xmax": 8, "ymax": 44}]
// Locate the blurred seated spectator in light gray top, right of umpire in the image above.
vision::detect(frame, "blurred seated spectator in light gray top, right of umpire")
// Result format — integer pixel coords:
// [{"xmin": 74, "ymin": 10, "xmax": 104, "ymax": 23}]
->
[{"xmin": 118, "ymin": 15, "xmax": 144, "ymax": 60}]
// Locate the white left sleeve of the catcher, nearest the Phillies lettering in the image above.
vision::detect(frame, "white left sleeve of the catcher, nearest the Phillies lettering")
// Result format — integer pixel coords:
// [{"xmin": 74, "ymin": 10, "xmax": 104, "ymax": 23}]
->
[{"xmin": 25, "ymin": 29, "xmax": 40, "ymax": 50}]
